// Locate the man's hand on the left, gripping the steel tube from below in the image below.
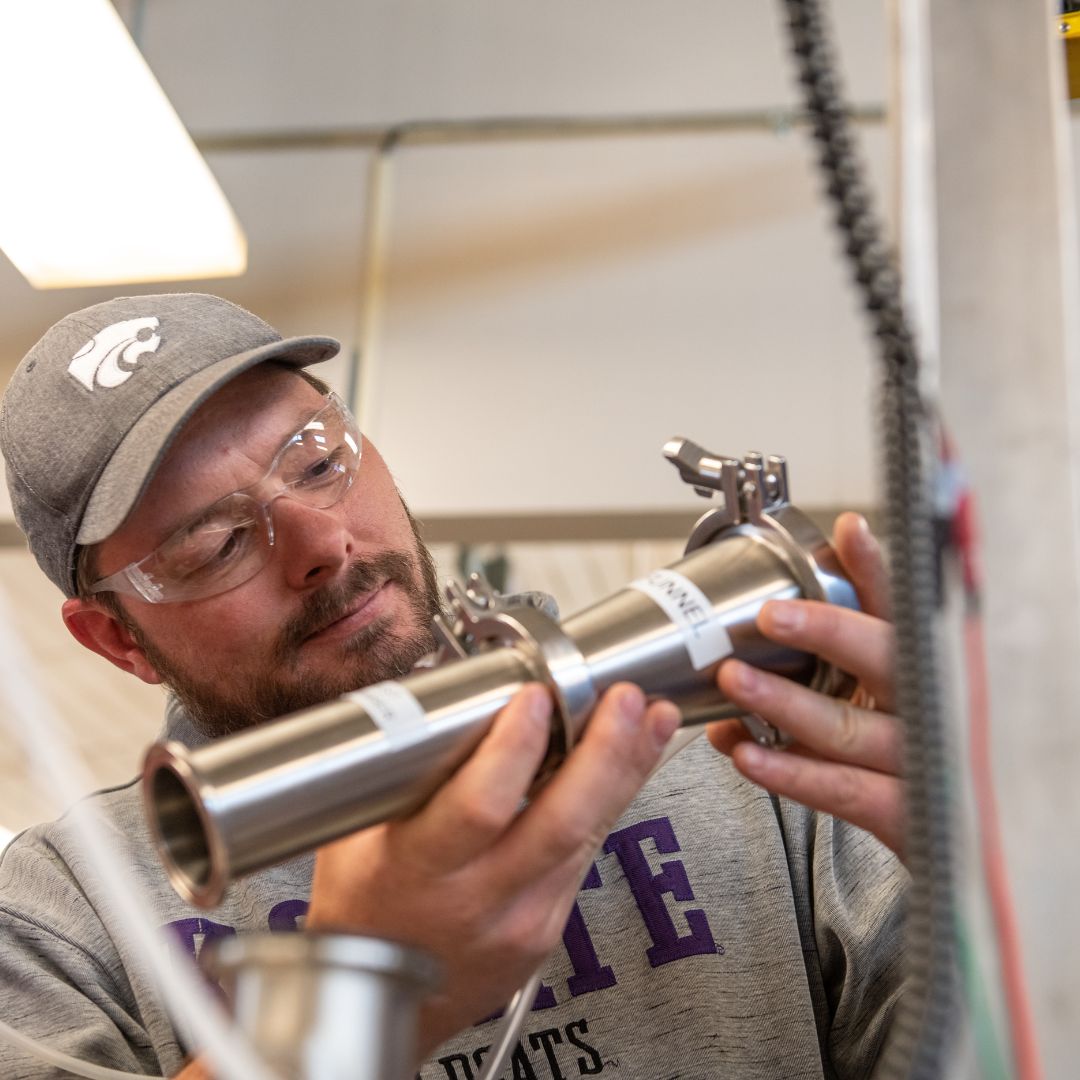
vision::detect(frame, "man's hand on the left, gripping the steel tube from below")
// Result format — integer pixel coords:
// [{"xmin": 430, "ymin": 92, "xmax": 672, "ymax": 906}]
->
[{"xmin": 307, "ymin": 684, "xmax": 679, "ymax": 1053}]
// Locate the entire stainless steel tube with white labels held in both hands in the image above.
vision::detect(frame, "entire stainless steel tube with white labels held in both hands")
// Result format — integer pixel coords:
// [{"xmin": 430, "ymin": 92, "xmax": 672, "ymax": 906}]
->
[{"xmin": 144, "ymin": 505, "xmax": 856, "ymax": 907}]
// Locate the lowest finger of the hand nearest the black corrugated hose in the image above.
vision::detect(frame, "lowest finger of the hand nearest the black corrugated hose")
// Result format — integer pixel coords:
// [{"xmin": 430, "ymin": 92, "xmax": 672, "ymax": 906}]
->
[{"xmin": 732, "ymin": 742, "xmax": 904, "ymax": 856}]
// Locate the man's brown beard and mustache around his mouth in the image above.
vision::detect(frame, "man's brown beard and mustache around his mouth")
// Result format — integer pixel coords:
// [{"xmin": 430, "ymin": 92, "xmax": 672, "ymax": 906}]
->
[{"xmin": 129, "ymin": 540, "xmax": 440, "ymax": 739}]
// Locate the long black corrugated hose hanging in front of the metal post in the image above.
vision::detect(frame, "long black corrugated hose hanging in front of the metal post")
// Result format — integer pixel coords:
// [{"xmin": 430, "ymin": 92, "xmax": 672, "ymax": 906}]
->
[{"xmin": 783, "ymin": 0, "xmax": 959, "ymax": 1080}]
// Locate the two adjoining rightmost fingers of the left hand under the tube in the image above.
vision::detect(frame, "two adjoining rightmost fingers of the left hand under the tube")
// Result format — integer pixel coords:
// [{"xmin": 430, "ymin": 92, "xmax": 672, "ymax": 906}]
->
[{"xmin": 495, "ymin": 684, "xmax": 680, "ymax": 881}]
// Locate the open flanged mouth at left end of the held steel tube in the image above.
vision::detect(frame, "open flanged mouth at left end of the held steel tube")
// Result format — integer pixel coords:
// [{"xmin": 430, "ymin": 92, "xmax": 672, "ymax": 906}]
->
[{"xmin": 143, "ymin": 742, "xmax": 229, "ymax": 907}]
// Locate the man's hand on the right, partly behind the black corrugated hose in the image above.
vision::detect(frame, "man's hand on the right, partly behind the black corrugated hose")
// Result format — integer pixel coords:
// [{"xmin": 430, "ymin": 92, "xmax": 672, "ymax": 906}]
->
[{"xmin": 708, "ymin": 513, "xmax": 904, "ymax": 855}]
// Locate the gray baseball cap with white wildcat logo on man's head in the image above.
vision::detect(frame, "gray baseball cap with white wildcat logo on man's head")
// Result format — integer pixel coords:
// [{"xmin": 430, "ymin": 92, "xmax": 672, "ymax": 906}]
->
[{"xmin": 0, "ymin": 293, "xmax": 340, "ymax": 596}]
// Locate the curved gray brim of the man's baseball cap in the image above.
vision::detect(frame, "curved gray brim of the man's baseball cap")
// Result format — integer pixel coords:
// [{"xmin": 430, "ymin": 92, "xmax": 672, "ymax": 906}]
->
[{"xmin": 76, "ymin": 337, "xmax": 340, "ymax": 544}]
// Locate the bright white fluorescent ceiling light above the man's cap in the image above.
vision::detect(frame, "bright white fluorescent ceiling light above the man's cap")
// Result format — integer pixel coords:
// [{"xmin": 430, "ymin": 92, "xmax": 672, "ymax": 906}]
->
[{"xmin": 0, "ymin": 0, "xmax": 247, "ymax": 288}]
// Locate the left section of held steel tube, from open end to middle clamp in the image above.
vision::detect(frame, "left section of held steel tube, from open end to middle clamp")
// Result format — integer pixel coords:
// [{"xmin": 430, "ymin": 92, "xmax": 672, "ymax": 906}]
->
[{"xmin": 143, "ymin": 648, "xmax": 532, "ymax": 907}]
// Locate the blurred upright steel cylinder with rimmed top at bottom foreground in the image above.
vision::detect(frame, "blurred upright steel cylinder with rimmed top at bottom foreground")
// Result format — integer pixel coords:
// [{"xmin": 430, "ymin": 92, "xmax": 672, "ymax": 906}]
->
[{"xmin": 200, "ymin": 933, "xmax": 440, "ymax": 1080}]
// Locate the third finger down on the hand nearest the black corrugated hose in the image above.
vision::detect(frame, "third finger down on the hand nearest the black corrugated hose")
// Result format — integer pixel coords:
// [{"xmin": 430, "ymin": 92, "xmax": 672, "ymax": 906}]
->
[{"xmin": 710, "ymin": 660, "xmax": 902, "ymax": 774}]
